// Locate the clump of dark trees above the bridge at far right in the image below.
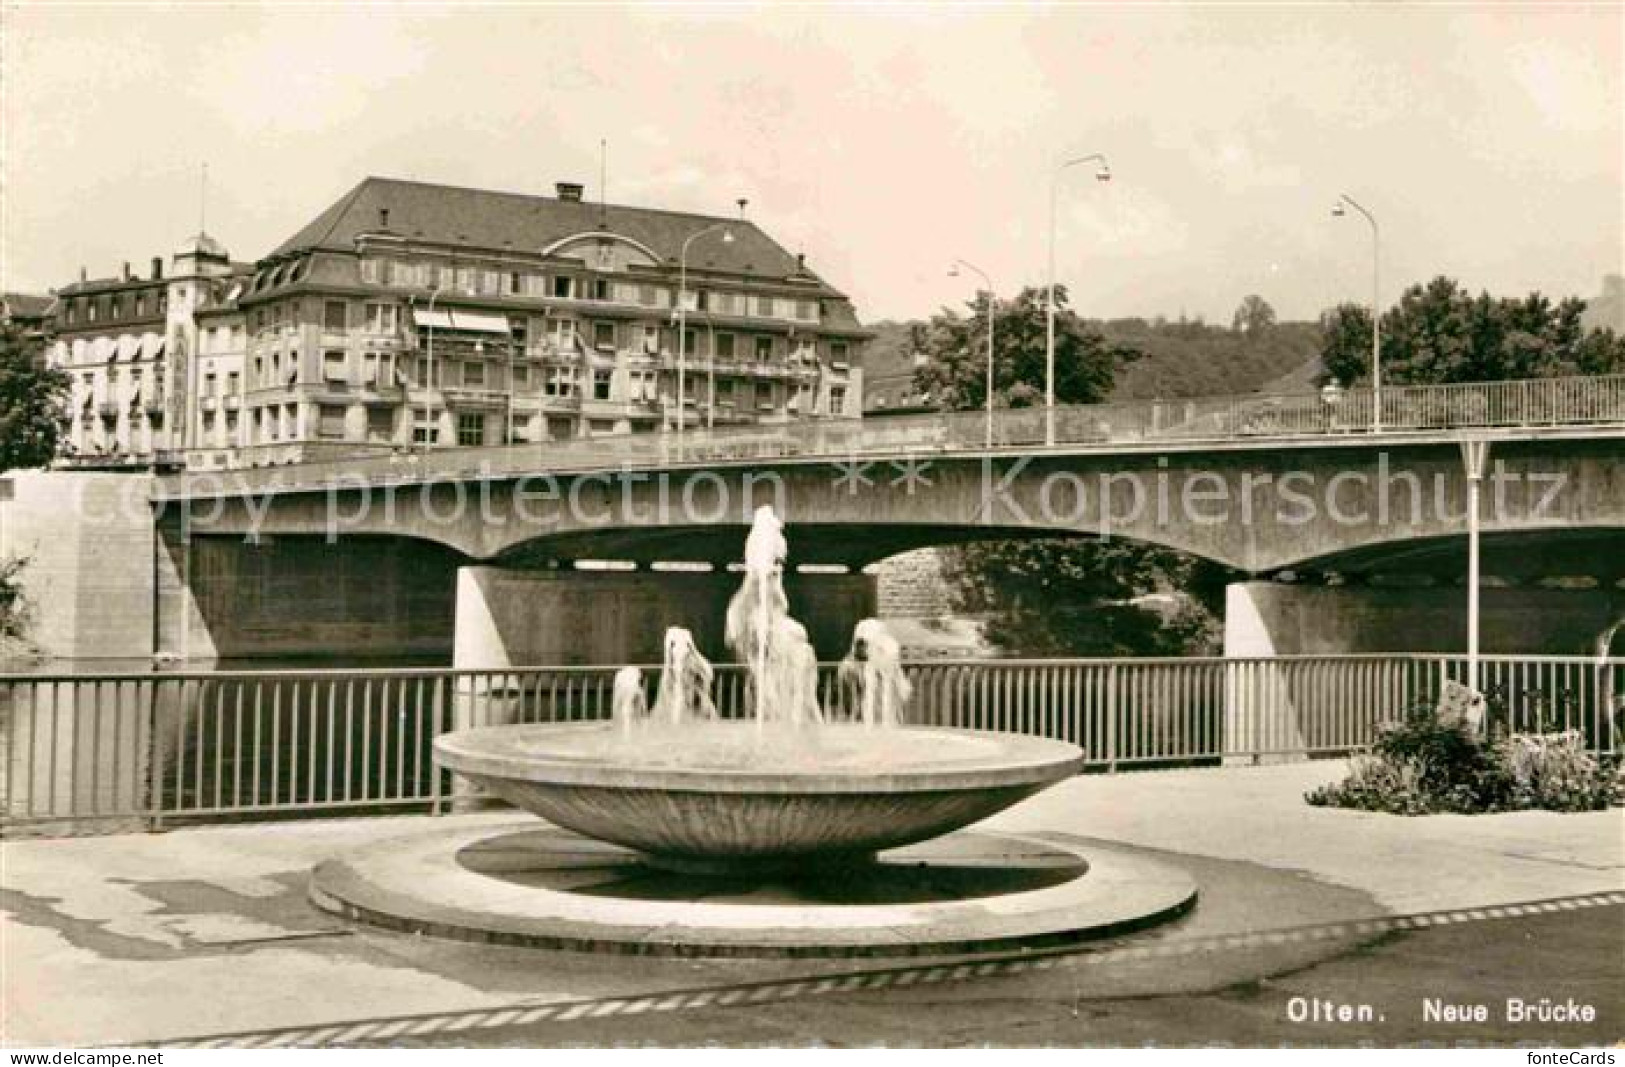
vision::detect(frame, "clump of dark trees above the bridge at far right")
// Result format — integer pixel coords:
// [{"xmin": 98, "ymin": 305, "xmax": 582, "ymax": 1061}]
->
[{"xmin": 1321, "ymin": 276, "xmax": 1625, "ymax": 385}]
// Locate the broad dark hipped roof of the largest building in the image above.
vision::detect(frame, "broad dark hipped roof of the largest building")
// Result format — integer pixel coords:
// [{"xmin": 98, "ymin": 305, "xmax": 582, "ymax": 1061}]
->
[{"xmin": 271, "ymin": 177, "xmax": 839, "ymax": 296}]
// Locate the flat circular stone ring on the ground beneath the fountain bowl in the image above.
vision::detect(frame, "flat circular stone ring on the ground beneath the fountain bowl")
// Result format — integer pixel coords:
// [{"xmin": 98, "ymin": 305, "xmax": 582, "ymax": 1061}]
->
[{"xmin": 310, "ymin": 820, "xmax": 1196, "ymax": 957}]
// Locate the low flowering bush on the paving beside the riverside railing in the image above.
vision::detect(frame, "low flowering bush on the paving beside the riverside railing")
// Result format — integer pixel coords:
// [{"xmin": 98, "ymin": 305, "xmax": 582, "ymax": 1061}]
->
[{"xmin": 1303, "ymin": 705, "xmax": 1625, "ymax": 815}]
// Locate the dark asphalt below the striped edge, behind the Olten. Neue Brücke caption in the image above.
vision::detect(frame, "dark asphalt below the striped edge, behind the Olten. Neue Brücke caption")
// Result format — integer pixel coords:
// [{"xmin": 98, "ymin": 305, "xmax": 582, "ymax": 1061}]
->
[{"xmin": 353, "ymin": 905, "xmax": 1625, "ymax": 1048}]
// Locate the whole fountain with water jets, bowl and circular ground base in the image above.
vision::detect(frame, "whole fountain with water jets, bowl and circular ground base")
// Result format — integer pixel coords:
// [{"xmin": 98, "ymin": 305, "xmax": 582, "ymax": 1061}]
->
[{"xmin": 312, "ymin": 507, "xmax": 1196, "ymax": 955}]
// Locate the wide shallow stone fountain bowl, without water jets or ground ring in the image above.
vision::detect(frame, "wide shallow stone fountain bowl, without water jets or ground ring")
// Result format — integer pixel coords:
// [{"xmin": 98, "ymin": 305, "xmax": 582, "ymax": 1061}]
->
[{"xmin": 434, "ymin": 721, "xmax": 1084, "ymax": 872}]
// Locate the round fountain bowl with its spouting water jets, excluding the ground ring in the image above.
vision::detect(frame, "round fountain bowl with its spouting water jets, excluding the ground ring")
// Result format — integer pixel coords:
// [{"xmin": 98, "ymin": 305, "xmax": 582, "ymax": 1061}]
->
[{"xmin": 434, "ymin": 507, "xmax": 1082, "ymax": 874}]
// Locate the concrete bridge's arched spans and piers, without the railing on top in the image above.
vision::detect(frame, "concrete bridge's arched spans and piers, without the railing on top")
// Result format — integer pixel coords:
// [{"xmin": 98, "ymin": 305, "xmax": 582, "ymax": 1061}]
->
[{"xmin": 146, "ymin": 426, "xmax": 1625, "ymax": 666}]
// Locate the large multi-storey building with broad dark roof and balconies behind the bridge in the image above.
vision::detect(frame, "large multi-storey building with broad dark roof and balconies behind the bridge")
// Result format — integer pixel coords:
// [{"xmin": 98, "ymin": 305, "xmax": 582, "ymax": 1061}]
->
[{"xmin": 208, "ymin": 177, "xmax": 868, "ymax": 466}]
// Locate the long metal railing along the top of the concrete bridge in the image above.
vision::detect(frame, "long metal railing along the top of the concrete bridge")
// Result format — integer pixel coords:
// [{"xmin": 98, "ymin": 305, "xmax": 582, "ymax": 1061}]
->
[{"xmin": 161, "ymin": 375, "xmax": 1625, "ymax": 494}]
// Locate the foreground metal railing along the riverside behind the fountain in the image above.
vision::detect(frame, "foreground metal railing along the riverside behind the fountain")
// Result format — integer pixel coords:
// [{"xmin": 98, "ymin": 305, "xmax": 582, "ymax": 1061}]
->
[{"xmin": 0, "ymin": 656, "xmax": 1625, "ymax": 832}]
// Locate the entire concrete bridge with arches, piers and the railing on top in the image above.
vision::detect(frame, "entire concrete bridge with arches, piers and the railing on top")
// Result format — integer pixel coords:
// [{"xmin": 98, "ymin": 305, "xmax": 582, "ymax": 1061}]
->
[{"xmin": 10, "ymin": 377, "xmax": 1625, "ymax": 666}]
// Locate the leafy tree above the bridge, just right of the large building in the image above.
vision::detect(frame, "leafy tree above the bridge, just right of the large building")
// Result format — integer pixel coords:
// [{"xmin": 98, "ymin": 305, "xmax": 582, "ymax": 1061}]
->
[{"xmin": 915, "ymin": 286, "xmax": 1139, "ymax": 411}]
